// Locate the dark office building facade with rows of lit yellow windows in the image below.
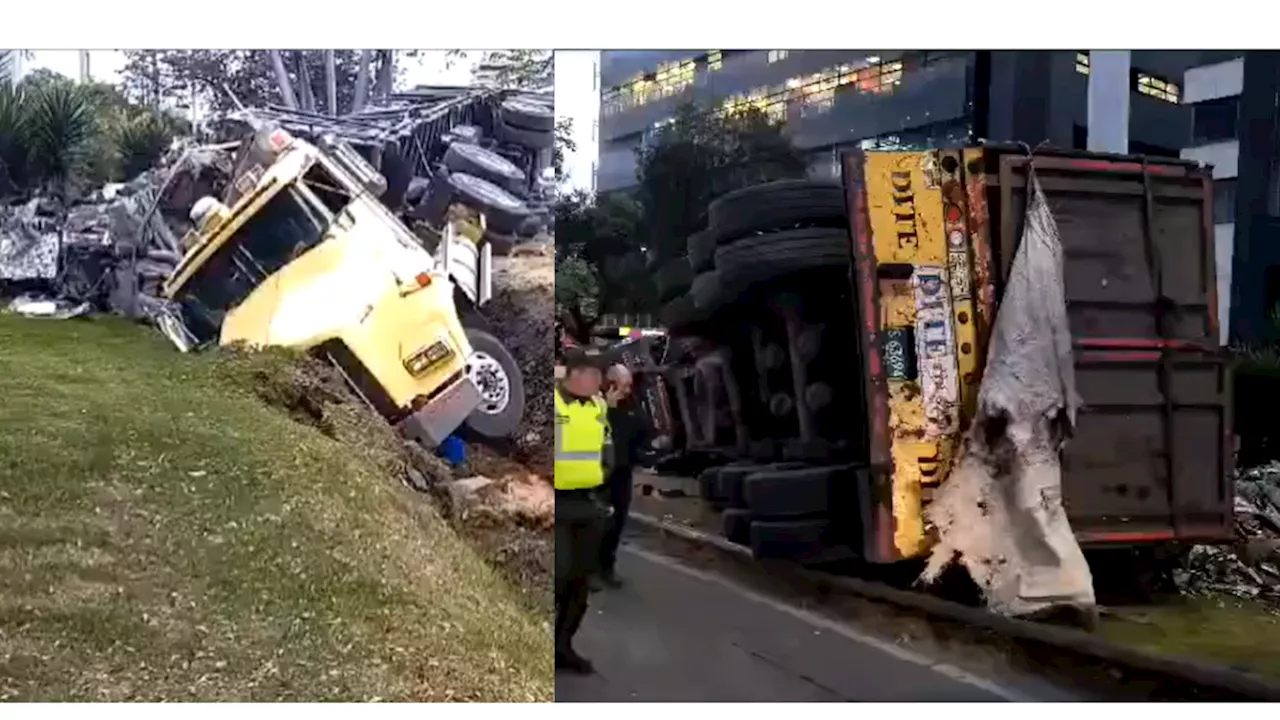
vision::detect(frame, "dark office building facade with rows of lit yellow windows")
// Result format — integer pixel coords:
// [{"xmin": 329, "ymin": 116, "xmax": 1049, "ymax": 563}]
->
[{"xmin": 595, "ymin": 50, "xmax": 1198, "ymax": 192}]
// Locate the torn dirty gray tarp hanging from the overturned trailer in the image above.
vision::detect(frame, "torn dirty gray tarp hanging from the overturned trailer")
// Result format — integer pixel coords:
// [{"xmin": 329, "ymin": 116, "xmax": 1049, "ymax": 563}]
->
[{"xmin": 924, "ymin": 169, "xmax": 1094, "ymax": 615}]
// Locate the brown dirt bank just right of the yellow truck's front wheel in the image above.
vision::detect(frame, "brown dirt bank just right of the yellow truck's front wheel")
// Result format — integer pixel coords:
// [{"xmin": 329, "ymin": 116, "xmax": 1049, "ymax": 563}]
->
[{"xmin": 485, "ymin": 256, "xmax": 556, "ymax": 477}]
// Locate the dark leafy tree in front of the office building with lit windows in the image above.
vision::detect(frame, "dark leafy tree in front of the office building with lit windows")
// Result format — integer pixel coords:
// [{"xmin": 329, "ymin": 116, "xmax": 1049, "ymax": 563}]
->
[{"xmin": 636, "ymin": 105, "xmax": 806, "ymax": 261}]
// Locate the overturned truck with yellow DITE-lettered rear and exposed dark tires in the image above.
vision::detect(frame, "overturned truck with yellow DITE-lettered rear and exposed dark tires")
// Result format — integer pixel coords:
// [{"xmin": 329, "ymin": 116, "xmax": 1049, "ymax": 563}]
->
[{"xmin": 658, "ymin": 146, "xmax": 1234, "ymax": 609}]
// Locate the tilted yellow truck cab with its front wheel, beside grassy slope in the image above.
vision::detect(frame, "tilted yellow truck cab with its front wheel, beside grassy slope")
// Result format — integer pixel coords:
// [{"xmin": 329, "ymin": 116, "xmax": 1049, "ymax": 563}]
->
[{"xmin": 164, "ymin": 129, "xmax": 524, "ymax": 447}]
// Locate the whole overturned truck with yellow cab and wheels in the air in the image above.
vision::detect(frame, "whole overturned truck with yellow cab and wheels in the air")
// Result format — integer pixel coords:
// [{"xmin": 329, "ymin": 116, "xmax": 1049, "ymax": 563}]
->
[{"xmin": 140, "ymin": 88, "xmax": 552, "ymax": 447}]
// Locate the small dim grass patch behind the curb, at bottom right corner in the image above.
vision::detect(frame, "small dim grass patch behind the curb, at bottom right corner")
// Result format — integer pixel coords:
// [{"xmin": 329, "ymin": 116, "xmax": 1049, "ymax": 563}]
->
[{"xmin": 1098, "ymin": 596, "xmax": 1280, "ymax": 679}]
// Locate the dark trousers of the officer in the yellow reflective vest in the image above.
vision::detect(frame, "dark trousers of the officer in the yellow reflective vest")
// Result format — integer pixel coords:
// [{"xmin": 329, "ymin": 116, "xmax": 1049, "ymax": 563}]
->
[{"xmin": 556, "ymin": 488, "xmax": 609, "ymax": 652}]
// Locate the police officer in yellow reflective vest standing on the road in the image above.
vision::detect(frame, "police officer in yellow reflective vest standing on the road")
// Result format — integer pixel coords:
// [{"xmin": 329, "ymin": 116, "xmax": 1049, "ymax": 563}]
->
[{"xmin": 556, "ymin": 348, "xmax": 609, "ymax": 675}]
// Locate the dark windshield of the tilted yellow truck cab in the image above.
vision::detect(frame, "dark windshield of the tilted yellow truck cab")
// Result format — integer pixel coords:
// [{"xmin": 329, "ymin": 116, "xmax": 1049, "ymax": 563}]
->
[{"xmin": 178, "ymin": 186, "xmax": 328, "ymax": 345}]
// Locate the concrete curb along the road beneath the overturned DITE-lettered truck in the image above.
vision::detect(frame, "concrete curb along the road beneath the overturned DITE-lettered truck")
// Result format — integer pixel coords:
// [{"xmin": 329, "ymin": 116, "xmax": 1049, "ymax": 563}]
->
[{"xmin": 628, "ymin": 512, "xmax": 1280, "ymax": 702}]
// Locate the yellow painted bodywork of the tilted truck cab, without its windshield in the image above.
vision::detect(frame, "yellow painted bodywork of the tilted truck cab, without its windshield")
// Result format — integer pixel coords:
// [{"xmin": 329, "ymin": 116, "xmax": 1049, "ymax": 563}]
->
[{"xmin": 164, "ymin": 133, "xmax": 471, "ymax": 411}]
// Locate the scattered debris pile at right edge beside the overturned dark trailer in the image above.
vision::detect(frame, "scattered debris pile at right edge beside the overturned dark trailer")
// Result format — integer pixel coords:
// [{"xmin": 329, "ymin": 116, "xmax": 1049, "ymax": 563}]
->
[{"xmin": 1174, "ymin": 462, "xmax": 1280, "ymax": 609}]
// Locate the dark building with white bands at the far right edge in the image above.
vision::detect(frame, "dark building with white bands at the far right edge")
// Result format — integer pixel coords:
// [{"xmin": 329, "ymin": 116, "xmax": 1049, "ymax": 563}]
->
[{"xmin": 1183, "ymin": 51, "xmax": 1280, "ymax": 342}]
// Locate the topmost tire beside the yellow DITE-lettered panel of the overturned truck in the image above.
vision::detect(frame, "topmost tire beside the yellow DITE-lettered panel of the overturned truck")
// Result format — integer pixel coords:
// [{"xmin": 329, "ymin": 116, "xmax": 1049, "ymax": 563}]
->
[{"xmin": 707, "ymin": 179, "xmax": 849, "ymax": 245}]
